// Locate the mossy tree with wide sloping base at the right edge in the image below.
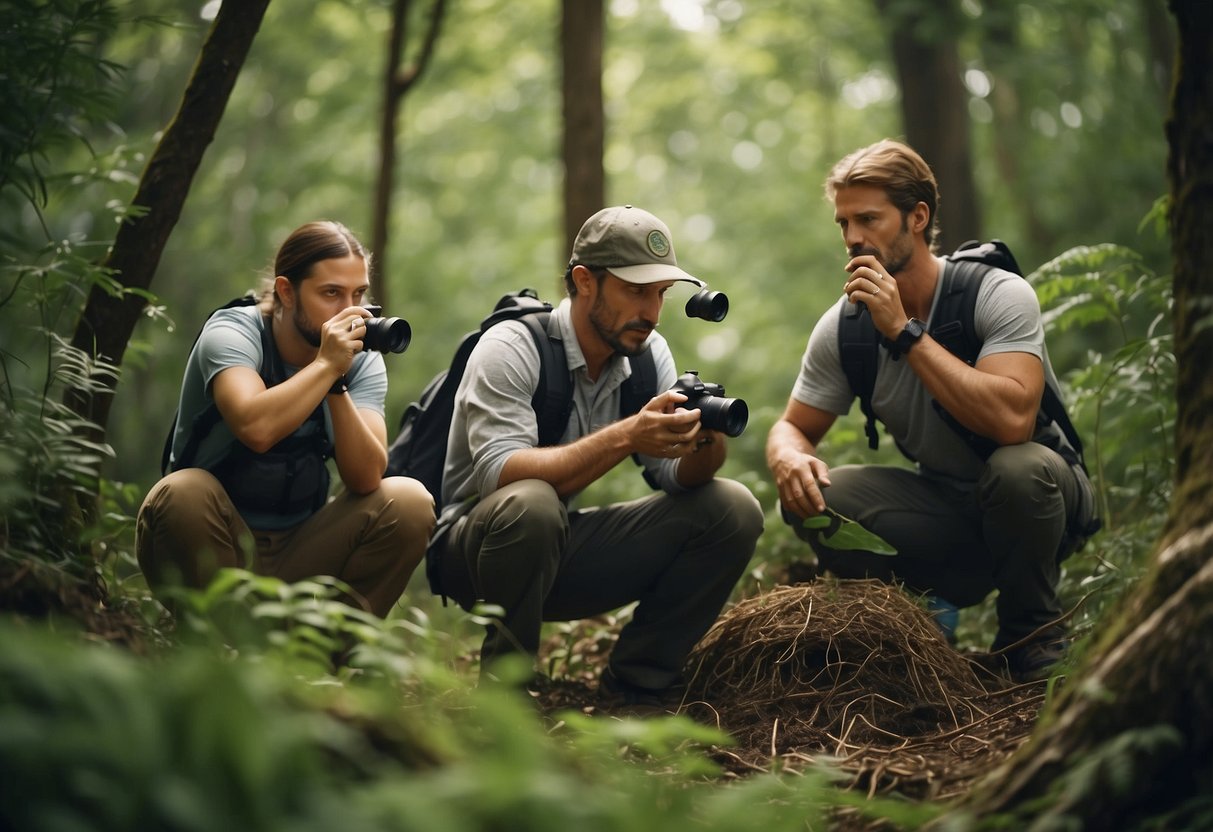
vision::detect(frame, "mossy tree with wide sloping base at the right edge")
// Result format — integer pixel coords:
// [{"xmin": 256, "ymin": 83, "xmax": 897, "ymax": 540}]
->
[{"xmin": 955, "ymin": 0, "xmax": 1213, "ymax": 830}]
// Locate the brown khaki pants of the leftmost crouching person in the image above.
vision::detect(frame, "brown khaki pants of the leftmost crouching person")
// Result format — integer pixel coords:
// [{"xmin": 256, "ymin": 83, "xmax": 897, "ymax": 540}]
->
[{"xmin": 136, "ymin": 468, "xmax": 434, "ymax": 616}]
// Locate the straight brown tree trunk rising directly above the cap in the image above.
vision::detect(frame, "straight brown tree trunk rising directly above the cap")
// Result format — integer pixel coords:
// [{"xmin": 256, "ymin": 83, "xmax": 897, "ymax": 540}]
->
[{"xmin": 560, "ymin": 0, "xmax": 607, "ymax": 265}]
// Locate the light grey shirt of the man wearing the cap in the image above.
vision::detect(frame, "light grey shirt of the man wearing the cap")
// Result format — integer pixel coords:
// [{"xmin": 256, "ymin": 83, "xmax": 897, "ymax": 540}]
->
[{"xmin": 443, "ymin": 298, "xmax": 684, "ymax": 507}]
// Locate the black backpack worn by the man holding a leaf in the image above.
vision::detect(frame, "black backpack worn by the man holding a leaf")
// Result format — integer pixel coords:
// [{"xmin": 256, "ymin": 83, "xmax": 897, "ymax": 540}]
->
[{"xmin": 838, "ymin": 240, "xmax": 1087, "ymax": 472}]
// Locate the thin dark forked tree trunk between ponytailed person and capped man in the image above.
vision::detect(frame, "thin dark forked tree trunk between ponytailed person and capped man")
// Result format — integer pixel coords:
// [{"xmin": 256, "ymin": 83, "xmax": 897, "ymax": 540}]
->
[{"xmin": 371, "ymin": 0, "xmax": 446, "ymax": 306}]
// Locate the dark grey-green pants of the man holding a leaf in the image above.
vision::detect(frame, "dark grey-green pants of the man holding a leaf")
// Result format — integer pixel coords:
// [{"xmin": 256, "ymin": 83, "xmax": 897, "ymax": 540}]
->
[{"xmin": 785, "ymin": 443, "xmax": 1081, "ymax": 648}]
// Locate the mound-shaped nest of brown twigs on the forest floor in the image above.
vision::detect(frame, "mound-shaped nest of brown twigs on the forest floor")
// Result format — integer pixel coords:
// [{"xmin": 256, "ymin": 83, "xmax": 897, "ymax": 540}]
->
[{"xmin": 536, "ymin": 579, "xmax": 1044, "ymax": 799}]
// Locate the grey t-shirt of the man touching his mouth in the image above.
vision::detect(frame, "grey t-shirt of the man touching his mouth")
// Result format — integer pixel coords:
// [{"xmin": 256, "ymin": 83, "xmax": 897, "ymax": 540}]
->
[{"xmin": 792, "ymin": 258, "xmax": 1055, "ymax": 483}]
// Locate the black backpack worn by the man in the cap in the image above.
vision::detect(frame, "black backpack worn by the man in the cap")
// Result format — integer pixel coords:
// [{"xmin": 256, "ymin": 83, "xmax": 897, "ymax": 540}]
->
[{"xmin": 383, "ymin": 289, "xmax": 657, "ymax": 509}]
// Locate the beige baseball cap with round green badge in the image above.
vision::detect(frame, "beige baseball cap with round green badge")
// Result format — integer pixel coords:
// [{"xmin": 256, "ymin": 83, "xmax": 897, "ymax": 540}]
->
[{"xmin": 569, "ymin": 205, "xmax": 706, "ymax": 286}]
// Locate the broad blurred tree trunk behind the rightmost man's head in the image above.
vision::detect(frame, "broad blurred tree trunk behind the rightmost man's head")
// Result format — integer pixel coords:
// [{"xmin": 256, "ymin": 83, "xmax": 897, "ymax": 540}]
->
[{"xmin": 876, "ymin": 0, "xmax": 981, "ymax": 251}]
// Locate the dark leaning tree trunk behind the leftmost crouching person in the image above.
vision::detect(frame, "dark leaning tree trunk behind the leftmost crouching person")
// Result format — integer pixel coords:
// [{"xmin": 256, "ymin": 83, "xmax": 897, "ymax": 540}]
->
[{"xmin": 64, "ymin": 0, "xmax": 269, "ymax": 439}]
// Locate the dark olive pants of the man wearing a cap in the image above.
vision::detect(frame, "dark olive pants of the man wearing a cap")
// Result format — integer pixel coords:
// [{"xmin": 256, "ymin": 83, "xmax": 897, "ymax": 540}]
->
[{"xmin": 432, "ymin": 479, "xmax": 763, "ymax": 689}]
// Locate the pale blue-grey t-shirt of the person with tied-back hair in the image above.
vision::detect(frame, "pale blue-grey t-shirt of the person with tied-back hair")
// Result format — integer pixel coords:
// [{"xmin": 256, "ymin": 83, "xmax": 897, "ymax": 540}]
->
[{"xmin": 170, "ymin": 306, "xmax": 387, "ymax": 529}]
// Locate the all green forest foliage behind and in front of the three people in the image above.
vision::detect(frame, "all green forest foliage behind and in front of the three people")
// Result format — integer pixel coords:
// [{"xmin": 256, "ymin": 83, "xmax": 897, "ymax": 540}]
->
[{"xmin": 0, "ymin": 0, "xmax": 1193, "ymax": 832}]
